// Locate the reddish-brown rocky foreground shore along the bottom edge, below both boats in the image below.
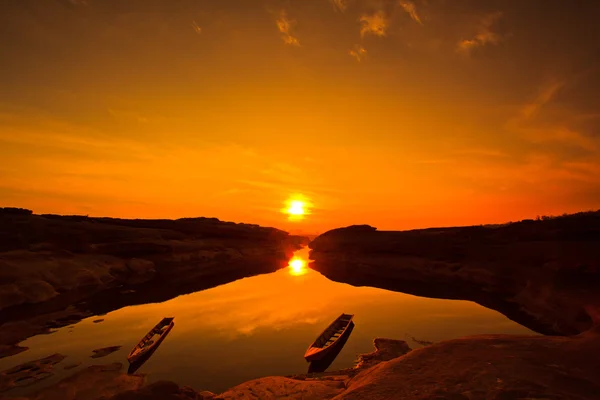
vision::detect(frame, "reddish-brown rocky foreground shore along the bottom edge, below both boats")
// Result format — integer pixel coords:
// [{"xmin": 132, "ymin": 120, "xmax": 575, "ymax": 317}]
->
[{"xmin": 9, "ymin": 332, "xmax": 600, "ymax": 400}]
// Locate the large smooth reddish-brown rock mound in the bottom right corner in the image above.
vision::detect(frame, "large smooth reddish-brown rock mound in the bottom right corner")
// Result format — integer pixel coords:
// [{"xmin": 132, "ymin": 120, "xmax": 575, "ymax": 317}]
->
[{"xmin": 335, "ymin": 335, "xmax": 600, "ymax": 400}]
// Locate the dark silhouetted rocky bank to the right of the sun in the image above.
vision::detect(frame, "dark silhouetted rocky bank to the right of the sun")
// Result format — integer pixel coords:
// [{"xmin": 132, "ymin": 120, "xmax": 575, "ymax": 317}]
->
[{"xmin": 309, "ymin": 212, "xmax": 600, "ymax": 335}]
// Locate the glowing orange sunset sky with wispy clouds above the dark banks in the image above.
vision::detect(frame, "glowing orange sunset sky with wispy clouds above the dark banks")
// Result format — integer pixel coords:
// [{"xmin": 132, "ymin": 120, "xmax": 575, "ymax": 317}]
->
[{"xmin": 0, "ymin": 0, "xmax": 600, "ymax": 232}]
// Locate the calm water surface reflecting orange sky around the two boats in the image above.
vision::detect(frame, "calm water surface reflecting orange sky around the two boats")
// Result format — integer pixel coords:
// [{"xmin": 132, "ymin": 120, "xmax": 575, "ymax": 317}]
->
[{"xmin": 0, "ymin": 250, "xmax": 534, "ymax": 396}]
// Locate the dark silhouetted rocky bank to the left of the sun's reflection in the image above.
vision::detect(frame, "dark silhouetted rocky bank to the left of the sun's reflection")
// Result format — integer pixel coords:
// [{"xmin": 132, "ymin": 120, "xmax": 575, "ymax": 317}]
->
[{"xmin": 0, "ymin": 208, "xmax": 308, "ymax": 357}]
